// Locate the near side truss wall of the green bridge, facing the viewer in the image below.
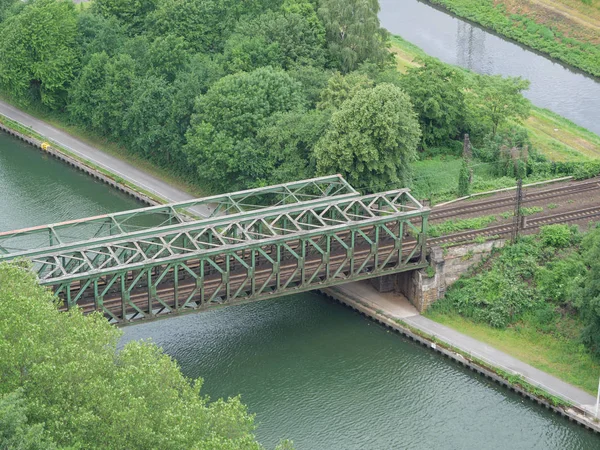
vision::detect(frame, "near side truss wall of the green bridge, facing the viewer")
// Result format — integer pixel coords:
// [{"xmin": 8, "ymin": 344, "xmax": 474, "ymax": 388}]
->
[{"xmin": 56, "ymin": 212, "xmax": 427, "ymax": 323}]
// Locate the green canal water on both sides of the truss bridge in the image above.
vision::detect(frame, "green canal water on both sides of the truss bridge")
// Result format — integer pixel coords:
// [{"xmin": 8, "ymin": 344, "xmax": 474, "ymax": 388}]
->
[{"xmin": 0, "ymin": 134, "xmax": 600, "ymax": 450}]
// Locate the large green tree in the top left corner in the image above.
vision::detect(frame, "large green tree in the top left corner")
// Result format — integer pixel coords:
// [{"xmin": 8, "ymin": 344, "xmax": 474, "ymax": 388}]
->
[{"xmin": 0, "ymin": 0, "xmax": 79, "ymax": 109}]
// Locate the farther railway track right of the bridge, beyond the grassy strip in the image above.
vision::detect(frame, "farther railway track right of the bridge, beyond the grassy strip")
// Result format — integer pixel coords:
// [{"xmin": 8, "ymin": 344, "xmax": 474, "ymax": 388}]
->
[{"xmin": 429, "ymin": 178, "xmax": 600, "ymax": 221}]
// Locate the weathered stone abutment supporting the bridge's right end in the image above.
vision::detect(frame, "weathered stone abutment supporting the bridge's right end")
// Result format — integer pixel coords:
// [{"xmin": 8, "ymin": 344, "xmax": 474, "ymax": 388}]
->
[{"xmin": 371, "ymin": 239, "xmax": 507, "ymax": 313}]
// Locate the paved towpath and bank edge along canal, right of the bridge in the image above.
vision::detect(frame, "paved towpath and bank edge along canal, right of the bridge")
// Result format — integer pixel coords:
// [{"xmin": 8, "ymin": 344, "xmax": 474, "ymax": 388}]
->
[{"xmin": 323, "ymin": 282, "xmax": 600, "ymax": 433}]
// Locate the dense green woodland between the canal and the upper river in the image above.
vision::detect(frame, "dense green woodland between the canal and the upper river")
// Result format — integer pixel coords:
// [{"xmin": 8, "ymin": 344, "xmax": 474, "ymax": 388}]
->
[{"xmin": 0, "ymin": 0, "xmax": 552, "ymax": 192}]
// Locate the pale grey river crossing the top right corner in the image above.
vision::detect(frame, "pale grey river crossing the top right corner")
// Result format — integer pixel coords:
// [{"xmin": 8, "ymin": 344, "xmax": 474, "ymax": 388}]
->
[{"xmin": 379, "ymin": 0, "xmax": 600, "ymax": 134}]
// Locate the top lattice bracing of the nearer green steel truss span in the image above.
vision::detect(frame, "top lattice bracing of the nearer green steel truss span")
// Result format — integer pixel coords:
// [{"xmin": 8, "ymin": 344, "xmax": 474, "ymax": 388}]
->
[{"xmin": 24, "ymin": 189, "xmax": 428, "ymax": 284}]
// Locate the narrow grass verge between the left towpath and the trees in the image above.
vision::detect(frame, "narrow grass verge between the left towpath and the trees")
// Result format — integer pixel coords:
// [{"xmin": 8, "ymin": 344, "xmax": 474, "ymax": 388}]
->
[{"xmin": 0, "ymin": 94, "xmax": 206, "ymax": 197}]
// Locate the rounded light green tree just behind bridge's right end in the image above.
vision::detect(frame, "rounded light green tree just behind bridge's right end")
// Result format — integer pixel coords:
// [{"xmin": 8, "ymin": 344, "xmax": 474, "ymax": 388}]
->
[{"xmin": 315, "ymin": 83, "xmax": 421, "ymax": 191}]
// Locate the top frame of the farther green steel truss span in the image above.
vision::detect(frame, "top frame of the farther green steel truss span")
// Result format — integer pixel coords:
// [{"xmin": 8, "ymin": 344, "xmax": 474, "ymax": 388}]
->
[{"xmin": 0, "ymin": 175, "xmax": 359, "ymax": 261}]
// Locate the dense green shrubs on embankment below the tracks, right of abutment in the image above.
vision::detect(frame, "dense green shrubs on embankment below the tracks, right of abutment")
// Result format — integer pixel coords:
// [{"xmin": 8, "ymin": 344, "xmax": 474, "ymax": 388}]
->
[{"xmin": 433, "ymin": 225, "xmax": 600, "ymax": 356}]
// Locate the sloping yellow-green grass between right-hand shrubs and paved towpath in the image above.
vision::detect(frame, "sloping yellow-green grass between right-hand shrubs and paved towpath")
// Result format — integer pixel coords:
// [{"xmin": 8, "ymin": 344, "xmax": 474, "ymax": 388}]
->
[{"xmin": 426, "ymin": 311, "xmax": 600, "ymax": 395}]
